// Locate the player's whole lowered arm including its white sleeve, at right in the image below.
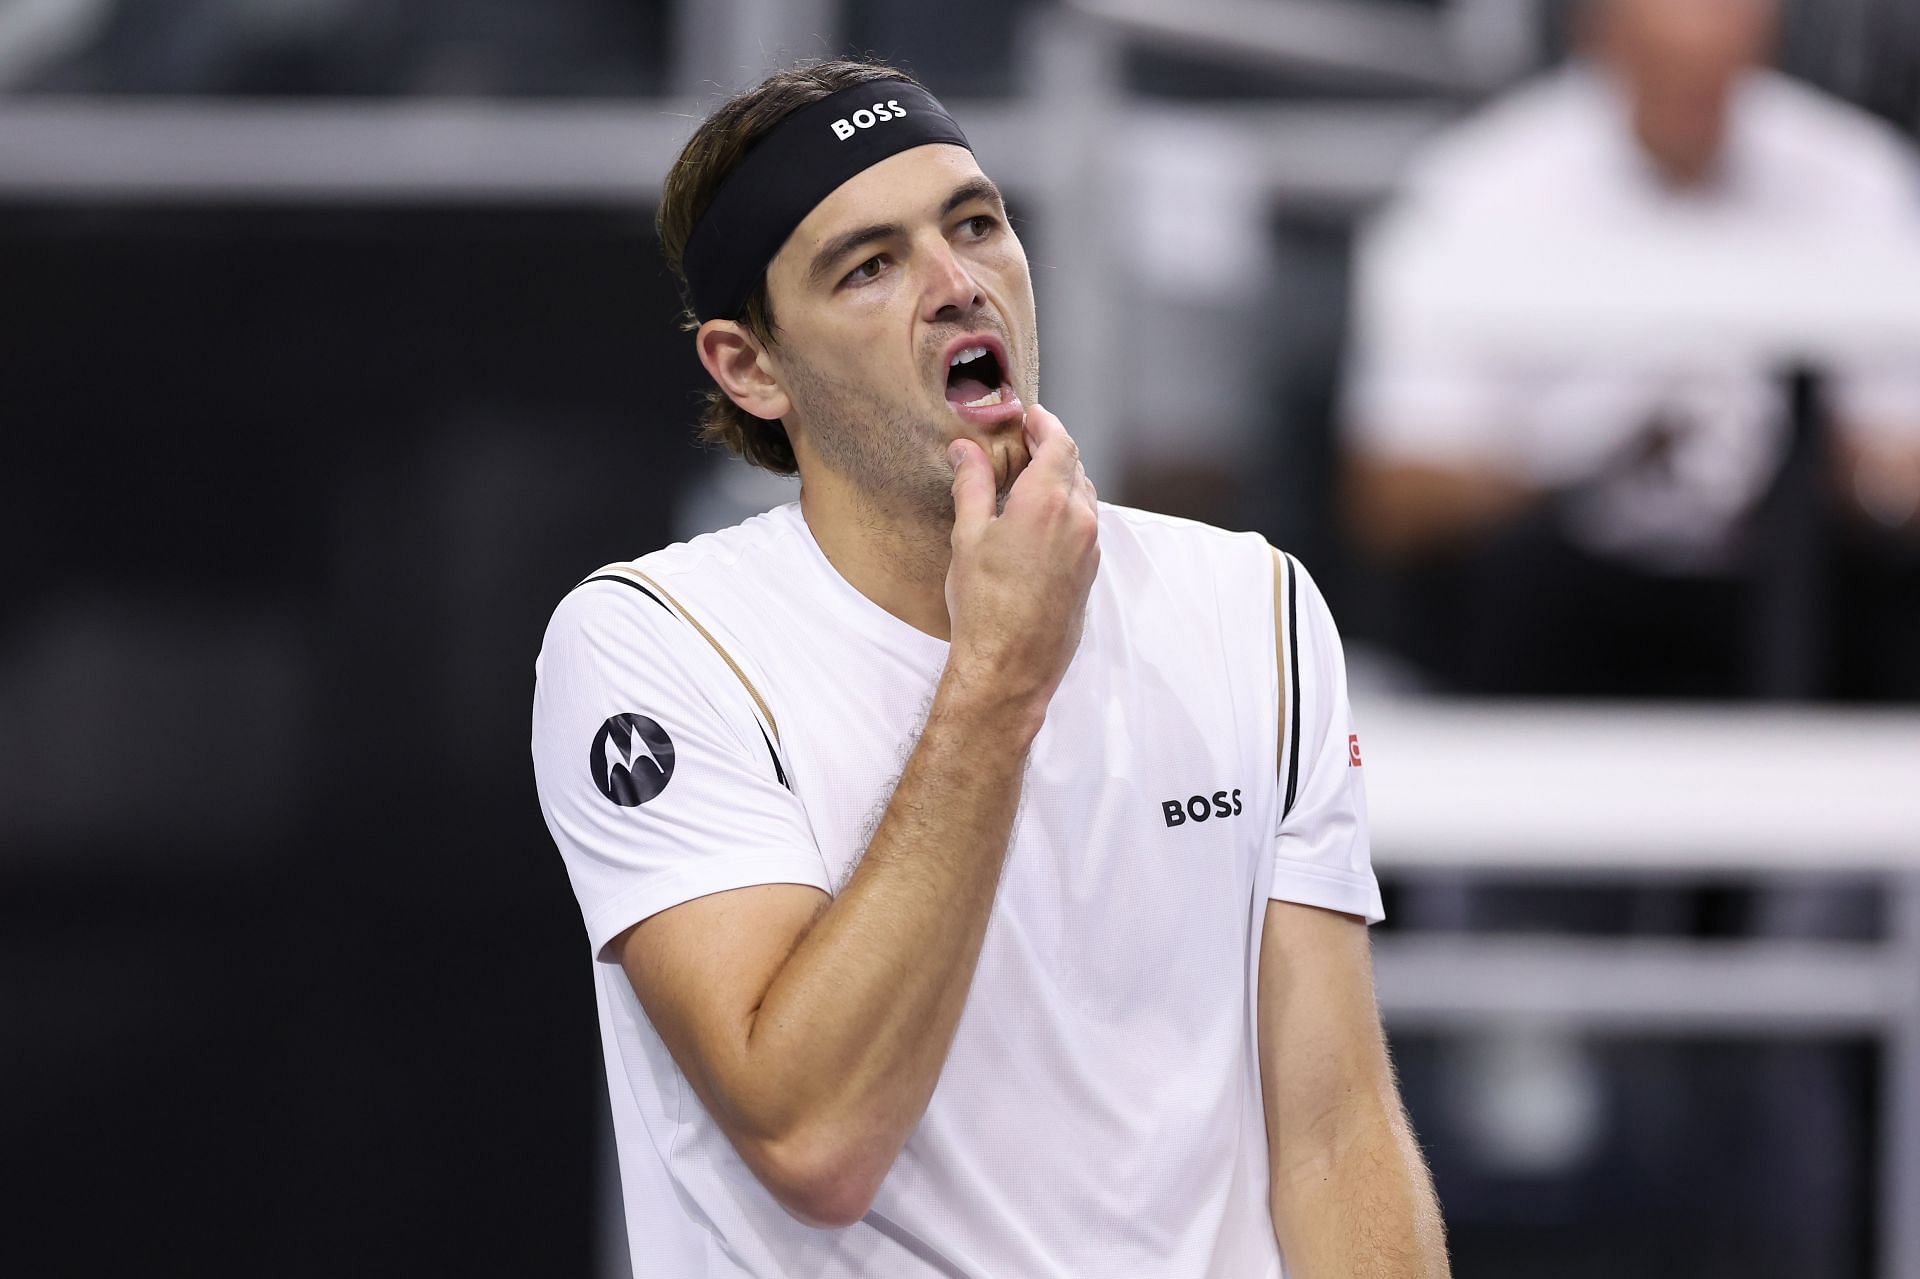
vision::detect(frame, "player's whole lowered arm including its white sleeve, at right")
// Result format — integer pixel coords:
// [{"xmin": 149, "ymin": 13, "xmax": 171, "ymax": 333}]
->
[{"xmin": 1260, "ymin": 553, "xmax": 1448, "ymax": 1279}]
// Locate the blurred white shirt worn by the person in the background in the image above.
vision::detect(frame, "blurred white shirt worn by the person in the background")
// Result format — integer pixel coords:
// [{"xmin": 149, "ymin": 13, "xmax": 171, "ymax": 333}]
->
[{"xmin": 1344, "ymin": 65, "xmax": 1920, "ymax": 568}]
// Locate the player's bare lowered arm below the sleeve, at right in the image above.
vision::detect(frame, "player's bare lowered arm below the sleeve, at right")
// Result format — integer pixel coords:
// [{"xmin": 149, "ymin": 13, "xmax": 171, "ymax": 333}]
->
[{"xmin": 1260, "ymin": 901, "xmax": 1448, "ymax": 1279}]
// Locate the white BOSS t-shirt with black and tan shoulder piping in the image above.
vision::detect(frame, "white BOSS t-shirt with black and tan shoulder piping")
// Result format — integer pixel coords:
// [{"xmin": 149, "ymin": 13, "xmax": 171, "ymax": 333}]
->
[{"xmin": 534, "ymin": 505, "xmax": 1380, "ymax": 1279}]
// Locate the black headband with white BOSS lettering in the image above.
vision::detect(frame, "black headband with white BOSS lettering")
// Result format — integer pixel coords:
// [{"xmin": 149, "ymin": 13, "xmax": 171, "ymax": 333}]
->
[{"xmin": 680, "ymin": 81, "xmax": 973, "ymax": 323}]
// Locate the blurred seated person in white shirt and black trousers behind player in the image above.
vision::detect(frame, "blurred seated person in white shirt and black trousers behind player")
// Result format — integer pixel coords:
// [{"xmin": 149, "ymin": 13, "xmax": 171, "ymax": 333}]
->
[{"xmin": 1344, "ymin": 0, "xmax": 1920, "ymax": 697}]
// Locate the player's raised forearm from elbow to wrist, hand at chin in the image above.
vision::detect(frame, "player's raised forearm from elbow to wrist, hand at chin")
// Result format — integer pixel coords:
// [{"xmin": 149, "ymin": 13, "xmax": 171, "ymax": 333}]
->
[{"xmin": 747, "ymin": 678, "xmax": 1039, "ymax": 1179}]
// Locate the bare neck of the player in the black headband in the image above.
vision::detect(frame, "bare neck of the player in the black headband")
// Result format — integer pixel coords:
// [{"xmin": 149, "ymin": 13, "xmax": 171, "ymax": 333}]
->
[{"xmin": 801, "ymin": 472, "xmax": 952, "ymax": 640}]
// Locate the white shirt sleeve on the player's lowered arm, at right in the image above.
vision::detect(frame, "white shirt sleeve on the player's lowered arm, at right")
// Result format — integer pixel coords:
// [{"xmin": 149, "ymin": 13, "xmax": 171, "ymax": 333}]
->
[{"xmin": 1267, "ymin": 555, "xmax": 1386, "ymax": 924}]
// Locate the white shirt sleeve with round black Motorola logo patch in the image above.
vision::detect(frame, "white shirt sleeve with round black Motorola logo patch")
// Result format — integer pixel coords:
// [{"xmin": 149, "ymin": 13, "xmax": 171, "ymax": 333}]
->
[{"xmin": 534, "ymin": 582, "xmax": 829, "ymax": 962}]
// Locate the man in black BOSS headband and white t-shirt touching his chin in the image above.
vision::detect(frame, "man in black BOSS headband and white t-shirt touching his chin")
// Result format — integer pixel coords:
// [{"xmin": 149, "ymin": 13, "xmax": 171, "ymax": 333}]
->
[{"xmin": 534, "ymin": 61, "xmax": 1446, "ymax": 1279}]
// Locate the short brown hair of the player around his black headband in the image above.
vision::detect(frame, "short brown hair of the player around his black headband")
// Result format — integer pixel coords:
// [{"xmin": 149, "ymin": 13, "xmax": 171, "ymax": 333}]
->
[{"xmin": 655, "ymin": 60, "xmax": 914, "ymax": 474}]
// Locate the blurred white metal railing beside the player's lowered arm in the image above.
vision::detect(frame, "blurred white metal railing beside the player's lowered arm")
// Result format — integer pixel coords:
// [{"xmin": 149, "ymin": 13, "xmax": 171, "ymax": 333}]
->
[{"xmin": 1359, "ymin": 703, "xmax": 1920, "ymax": 1279}]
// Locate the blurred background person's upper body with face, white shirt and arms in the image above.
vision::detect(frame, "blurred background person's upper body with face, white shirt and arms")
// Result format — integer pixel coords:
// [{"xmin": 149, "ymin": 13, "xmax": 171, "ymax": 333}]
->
[{"xmin": 1346, "ymin": 0, "xmax": 1920, "ymax": 572}]
